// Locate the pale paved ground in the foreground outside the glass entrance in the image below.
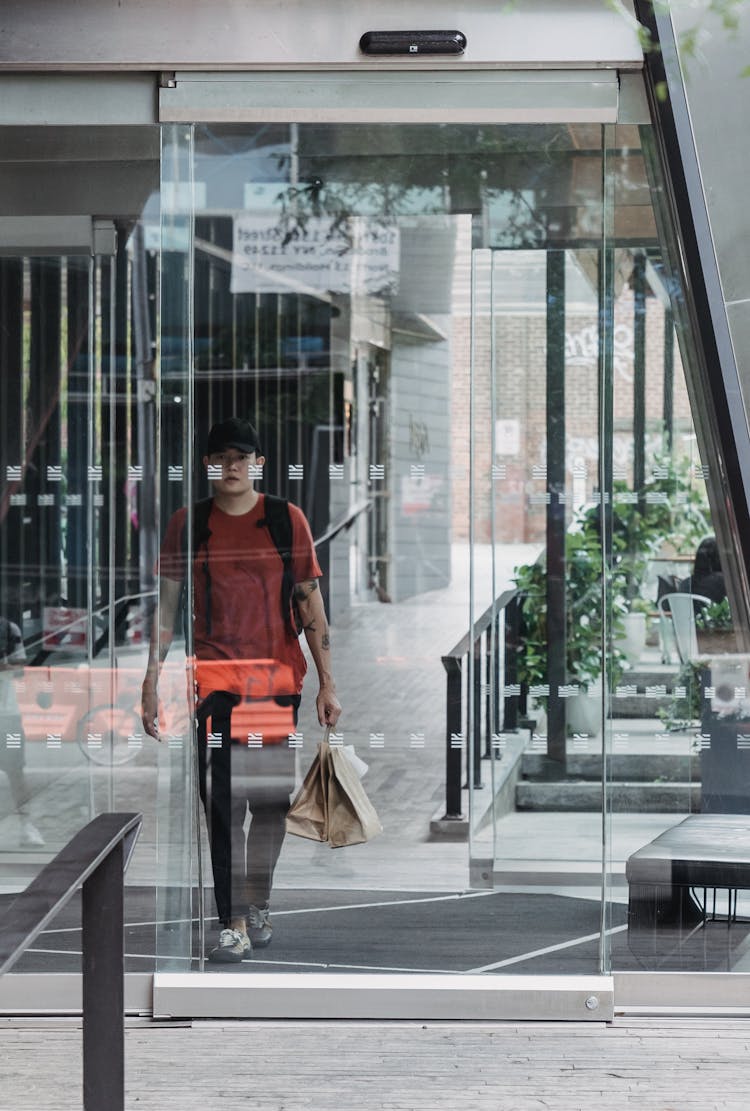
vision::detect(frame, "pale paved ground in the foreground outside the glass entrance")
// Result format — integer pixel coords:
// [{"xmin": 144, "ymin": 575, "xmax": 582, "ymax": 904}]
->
[{"xmin": 0, "ymin": 1018, "xmax": 750, "ymax": 1111}]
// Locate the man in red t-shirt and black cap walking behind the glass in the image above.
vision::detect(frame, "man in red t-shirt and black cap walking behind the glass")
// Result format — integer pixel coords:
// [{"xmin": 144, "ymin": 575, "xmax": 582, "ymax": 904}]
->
[{"xmin": 142, "ymin": 418, "xmax": 341, "ymax": 962}]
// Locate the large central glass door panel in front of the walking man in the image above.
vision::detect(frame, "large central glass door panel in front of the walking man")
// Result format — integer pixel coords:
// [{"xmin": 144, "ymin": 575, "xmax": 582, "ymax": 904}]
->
[{"xmin": 152, "ymin": 117, "xmax": 630, "ymax": 972}]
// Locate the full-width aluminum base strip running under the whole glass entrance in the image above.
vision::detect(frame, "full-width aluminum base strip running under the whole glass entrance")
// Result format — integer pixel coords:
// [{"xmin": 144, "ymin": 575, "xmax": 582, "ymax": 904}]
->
[{"xmin": 0, "ymin": 971, "xmax": 750, "ymax": 1022}]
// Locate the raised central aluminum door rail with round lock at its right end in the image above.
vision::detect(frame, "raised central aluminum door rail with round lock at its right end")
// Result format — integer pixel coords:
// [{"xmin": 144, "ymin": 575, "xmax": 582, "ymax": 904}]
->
[{"xmin": 153, "ymin": 972, "xmax": 614, "ymax": 1022}]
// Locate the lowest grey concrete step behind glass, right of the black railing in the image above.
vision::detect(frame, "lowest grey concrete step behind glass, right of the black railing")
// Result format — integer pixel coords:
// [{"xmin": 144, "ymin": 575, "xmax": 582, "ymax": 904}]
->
[{"xmin": 516, "ymin": 780, "xmax": 701, "ymax": 813}]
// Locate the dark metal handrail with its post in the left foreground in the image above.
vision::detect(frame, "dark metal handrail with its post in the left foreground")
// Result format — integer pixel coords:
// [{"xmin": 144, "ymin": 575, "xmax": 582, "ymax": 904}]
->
[{"xmin": 0, "ymin": 813, "xmax": 143, "ymax": 1111}]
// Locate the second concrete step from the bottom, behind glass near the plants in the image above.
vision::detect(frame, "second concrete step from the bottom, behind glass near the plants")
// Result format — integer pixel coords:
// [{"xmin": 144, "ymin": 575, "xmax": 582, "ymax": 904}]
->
[{"xmin": 521, "ymin": 752, "xmax": 700, "ymax": 783}]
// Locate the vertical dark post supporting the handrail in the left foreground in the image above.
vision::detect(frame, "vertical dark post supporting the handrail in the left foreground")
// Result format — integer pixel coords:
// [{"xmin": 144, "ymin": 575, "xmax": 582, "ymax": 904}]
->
[{"xmin": 81, "ymin": 841, "xmax": 124, "ymax": 1111}]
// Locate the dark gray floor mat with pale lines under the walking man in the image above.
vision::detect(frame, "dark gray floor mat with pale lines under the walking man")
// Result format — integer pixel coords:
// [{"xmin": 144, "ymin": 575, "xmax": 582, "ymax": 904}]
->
[{"xmin": 0, "ymin": 887, "xmax": 750, "ymax": 974}]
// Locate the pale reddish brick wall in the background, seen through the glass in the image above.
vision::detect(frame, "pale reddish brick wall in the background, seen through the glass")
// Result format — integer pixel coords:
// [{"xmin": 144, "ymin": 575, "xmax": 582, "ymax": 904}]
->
[{"xmin": 451, "ymin": 288, "xmax": 692, "ymax": 543}]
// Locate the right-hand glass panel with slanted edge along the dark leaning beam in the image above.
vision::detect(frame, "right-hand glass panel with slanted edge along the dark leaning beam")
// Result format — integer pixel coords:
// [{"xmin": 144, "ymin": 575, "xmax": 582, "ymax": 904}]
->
[{"xmin": 607, "ymin": 121, "xmax": 748, "ymax": 971}]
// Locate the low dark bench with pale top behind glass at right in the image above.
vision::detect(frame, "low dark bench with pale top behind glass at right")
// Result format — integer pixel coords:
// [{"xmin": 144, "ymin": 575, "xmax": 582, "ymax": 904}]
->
[{"xmin": 626, "ymin": 814, "xmax": 750, "ymax": 963}]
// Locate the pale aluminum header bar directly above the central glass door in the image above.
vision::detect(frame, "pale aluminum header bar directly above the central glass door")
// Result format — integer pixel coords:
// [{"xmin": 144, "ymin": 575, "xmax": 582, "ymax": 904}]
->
[{"xmin": 159, "ymin": 70, "xmax": 620, "ymax": 123}]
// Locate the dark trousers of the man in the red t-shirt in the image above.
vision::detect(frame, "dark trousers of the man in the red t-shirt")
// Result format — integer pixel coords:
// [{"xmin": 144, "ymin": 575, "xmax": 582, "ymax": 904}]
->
[{"xmin": 198, "ymin": 691, "xmax": 300, "ymax": 925}]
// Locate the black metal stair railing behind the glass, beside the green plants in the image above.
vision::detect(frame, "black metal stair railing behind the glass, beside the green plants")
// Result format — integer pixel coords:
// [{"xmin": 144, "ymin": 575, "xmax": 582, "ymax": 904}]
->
[{"xmin": 441, "ymin": 589, "xmax": 522, "ymax": 821}]
